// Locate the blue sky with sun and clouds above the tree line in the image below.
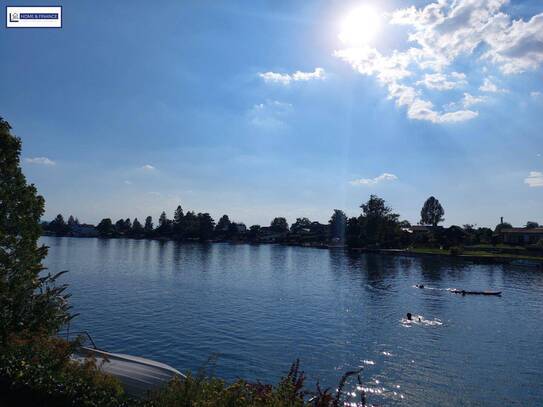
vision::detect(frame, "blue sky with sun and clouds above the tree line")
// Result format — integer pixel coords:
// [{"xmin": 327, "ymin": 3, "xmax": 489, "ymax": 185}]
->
[{"xmin": 0, "ymin": 0, "xmax": 543, "ymax": 227}]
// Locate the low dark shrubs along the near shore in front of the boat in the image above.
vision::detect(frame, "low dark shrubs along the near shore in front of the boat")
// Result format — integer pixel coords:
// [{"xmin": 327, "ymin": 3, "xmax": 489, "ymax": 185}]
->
[{"xmin": 0, "ymin": 335, "xmax": 365, "ymax": 407}]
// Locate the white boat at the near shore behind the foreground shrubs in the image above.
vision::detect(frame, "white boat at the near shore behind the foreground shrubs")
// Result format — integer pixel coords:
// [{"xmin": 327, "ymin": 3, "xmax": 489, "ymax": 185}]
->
[{"xmin": 72, "ymin": 336, "xmax": 186, "ymax": 397}]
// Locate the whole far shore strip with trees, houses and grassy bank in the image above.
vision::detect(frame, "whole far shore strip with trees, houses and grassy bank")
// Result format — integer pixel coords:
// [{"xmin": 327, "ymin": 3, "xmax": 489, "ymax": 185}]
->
[{"xmin": 42, "ymin": 195, "xmax": 543, "ymax": 258}]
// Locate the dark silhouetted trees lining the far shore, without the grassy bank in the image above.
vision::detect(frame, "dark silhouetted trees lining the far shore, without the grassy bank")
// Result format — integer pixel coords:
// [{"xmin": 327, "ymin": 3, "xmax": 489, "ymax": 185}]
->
[{"xmin": 44, "ymin": 195, "xmax": 538, "ymax": 248}]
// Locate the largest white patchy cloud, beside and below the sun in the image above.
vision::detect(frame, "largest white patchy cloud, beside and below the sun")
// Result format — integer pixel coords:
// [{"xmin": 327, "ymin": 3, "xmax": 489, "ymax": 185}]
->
[{"xmin": 334, "ymin": 0, "xmax": 543, "ymax": 123}]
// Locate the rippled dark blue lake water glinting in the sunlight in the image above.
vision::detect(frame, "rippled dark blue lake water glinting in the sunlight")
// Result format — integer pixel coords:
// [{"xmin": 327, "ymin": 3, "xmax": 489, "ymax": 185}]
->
[{"xmin": 42, "ymin": 237, "xmax": 543, "ymax": 406}]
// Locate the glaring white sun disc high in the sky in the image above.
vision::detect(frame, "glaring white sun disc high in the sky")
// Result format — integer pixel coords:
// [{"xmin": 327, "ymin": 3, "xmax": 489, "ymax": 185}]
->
[{"xmin": 338, "ymin": 5, "xmax": 380, "ymax": 46}]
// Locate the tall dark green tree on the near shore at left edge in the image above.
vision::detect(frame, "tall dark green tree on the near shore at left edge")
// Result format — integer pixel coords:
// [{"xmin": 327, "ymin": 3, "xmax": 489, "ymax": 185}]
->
[{"xmin": 0, "ymin": 118, "xmax": 70, "ymax": 344}]
